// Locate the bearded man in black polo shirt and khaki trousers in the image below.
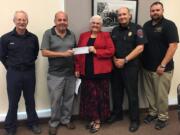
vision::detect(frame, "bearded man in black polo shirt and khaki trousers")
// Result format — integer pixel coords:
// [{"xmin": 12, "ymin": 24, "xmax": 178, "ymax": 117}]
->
[{"xmin": 142, "ymin": 2, "xmax": 179, "ymax": 129}]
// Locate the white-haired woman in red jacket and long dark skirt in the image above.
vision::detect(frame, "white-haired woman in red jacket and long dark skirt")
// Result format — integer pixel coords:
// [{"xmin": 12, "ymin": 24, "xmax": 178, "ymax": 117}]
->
[{"xmin": 75, "ymin": 15, "xmax": 114, "ymax": 133}]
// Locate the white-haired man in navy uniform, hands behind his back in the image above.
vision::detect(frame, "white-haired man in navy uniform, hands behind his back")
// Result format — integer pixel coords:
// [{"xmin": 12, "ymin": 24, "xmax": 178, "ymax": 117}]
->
[{"xmin": 0, "ymin": 11, "xmax": 41, "ymax": 135}]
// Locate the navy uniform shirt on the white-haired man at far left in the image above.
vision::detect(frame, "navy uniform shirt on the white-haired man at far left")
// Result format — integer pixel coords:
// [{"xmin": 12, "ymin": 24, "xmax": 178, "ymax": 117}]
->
[{"xmin": 0, "ymin": 29, "xmax": 39, "ymax": 68}]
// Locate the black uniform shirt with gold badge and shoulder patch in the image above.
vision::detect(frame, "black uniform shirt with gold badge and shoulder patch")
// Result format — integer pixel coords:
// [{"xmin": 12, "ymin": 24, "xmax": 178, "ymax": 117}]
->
[{"xmin": 112, "ymin": 23, "xmax": 147, "ymax": 66}]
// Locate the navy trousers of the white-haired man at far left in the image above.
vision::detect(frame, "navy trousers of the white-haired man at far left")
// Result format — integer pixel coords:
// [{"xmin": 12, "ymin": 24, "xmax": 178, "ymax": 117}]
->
[{"xmin": 5, "ymin": 68, "xmax": 38, "ymax": 132}]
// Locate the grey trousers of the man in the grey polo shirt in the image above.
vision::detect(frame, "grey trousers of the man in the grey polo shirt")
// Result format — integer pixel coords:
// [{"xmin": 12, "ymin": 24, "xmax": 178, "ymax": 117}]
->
[{"xmin": 47, "ymin": 74, "xmax": 76, "ymax": 127}]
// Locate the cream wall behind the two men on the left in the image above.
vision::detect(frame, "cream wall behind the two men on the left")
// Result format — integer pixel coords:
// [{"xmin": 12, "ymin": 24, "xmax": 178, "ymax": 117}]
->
[{"xmin": 0, "ymin": 0, "xmax": 64, "ymax": 121}]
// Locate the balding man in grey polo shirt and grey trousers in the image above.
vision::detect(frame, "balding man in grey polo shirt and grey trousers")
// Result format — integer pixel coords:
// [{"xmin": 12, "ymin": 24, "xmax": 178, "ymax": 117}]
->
[{"xmin": 41, "ymin": 11, "xmax": 76, "ymax": 135}]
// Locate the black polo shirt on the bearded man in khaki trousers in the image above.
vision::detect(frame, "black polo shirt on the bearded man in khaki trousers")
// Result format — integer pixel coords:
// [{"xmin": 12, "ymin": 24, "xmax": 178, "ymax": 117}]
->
[{"xmin": 142, "ymin": 18, "xmax": 179, "ymax": 71}]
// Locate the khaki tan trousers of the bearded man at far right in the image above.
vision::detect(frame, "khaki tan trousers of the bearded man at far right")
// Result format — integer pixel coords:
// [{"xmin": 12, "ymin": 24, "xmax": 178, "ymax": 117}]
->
[{"xmin": 143, "ymin": 69, "xmax": 173, "ymax": 121}]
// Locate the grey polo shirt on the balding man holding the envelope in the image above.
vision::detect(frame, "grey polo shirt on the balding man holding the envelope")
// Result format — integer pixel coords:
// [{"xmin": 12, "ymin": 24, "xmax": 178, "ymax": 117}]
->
[{"xmin": 41, "ymin": 27, "xmax": 76, "ymax": 76}]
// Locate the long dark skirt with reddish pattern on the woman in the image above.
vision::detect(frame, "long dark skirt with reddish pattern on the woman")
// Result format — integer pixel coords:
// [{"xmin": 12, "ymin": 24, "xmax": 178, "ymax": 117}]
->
[{"xmin": 80, "ymin": 79, "xmax": 110, "ymax": 121}]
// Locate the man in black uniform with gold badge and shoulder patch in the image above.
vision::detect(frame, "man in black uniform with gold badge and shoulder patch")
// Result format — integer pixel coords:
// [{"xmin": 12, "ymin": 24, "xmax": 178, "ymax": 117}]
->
[{"xmin": 109, "ymin": 7, "xmax": 146, "ymax": 132}]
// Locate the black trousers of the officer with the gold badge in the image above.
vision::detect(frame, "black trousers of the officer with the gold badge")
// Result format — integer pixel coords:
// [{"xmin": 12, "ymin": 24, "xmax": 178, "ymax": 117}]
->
[{"xmin": 112, "ymin": 67, "xmax": 139, "ymax": 122}]
